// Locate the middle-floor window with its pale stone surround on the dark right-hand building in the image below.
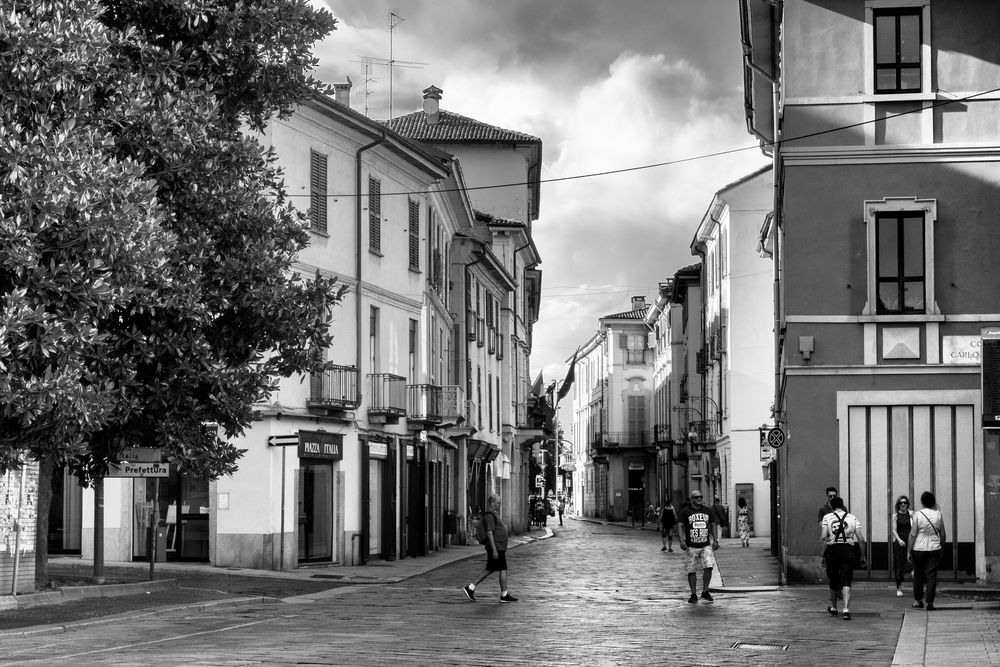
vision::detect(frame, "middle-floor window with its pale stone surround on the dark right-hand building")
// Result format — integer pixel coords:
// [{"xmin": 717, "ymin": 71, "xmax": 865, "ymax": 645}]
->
[{"xmin": 863, "ymin": 197, "xmax": 938, "ymax": 315}]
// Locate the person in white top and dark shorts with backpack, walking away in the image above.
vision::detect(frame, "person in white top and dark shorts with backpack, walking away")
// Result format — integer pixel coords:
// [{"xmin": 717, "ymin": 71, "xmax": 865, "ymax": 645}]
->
[{"xmin": 820, "ymin": 496, "xmax": 865, "ymax": 621}]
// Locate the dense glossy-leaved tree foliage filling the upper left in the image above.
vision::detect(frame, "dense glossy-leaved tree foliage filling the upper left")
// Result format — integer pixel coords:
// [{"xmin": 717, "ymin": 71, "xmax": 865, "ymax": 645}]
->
[{"xmin": 0, "ymin": 0, "xmax": 342, "ymax": 483}]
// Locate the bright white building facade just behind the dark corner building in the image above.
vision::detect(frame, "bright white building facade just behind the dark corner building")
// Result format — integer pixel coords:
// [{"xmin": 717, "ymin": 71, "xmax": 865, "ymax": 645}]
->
[{"xmin": 688, "ymin": 166, "xmax": 774, "ymax": 536}]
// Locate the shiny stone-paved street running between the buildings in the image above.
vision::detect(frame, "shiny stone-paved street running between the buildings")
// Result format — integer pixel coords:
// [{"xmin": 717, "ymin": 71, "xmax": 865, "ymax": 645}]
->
[{"xmin": 0, "ymin": 520, "xmax": 905, "ymax": 665}]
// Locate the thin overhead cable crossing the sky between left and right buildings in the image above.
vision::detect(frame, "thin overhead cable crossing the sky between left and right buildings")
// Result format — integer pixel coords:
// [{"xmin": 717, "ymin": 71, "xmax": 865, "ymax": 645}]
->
[{"xmin": 287, "ymin": 88, "xmax": 1000, "ymax": 198}]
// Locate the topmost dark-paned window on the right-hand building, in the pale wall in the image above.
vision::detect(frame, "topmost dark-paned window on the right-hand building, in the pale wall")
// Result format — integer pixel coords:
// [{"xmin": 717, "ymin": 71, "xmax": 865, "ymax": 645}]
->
[{"xmin": 872, "ymin": 7, "xmax": 923, "ymax": 93}]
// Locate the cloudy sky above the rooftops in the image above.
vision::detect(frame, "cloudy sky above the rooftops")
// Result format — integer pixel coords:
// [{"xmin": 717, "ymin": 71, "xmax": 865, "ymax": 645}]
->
[{"xmin": 312, "ymin": 0, "xmax": 768, "ymax": 384}]
